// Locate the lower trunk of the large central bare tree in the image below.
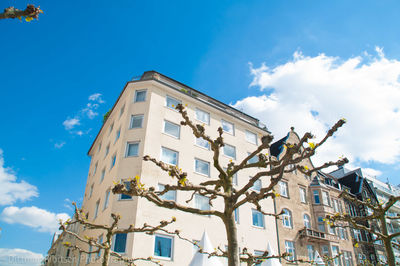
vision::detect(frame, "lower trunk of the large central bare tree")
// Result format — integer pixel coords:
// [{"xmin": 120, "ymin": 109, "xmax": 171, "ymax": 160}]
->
[{"xmin": 224, "ymin": 212, "xmax": 240, "ymax": 266}]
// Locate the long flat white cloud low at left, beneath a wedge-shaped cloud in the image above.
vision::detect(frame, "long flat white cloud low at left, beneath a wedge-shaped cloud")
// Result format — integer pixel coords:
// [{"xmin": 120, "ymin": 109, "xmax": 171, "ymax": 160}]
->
[{"xmin": 0, "ymin": 206, "xmax": 69, "ymax": 233}]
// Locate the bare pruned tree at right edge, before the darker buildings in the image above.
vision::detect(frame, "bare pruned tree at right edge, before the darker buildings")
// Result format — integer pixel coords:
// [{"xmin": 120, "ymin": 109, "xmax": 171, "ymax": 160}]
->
[{"xmin": 326, "ymin": 190, "xmax": 400, "ymax": 266}]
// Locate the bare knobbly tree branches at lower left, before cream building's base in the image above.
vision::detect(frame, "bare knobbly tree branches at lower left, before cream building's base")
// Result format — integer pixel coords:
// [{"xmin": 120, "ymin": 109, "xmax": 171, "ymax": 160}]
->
[{"xmin": 60, "ymin": 203, "xmax": 179, "ymax": 266}]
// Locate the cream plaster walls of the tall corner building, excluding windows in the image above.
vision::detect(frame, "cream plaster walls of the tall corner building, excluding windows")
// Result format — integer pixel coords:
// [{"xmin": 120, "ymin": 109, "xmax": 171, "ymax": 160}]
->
[{"xmin": 66, "ymin": 71, "xmax": 278, "ymax": 265}]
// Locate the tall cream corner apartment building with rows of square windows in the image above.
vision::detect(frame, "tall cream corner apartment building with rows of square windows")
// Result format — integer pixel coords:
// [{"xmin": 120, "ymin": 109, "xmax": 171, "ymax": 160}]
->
[{"xmin": 47, "ymin": 71, "xmax": 278, "ymax": 265}]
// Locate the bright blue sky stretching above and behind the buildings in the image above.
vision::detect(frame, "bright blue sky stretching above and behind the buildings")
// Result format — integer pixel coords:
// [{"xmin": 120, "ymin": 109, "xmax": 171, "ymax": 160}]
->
[{"xmin": 0, "ymin": 0, "xmax": 400, "ymax": 262}]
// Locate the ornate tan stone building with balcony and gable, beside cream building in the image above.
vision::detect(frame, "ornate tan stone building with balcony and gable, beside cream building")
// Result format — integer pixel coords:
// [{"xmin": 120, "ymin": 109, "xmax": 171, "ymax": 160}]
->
[{"xmin": 271, "ymin": 132, "xmax": 356, "ymax": 266}]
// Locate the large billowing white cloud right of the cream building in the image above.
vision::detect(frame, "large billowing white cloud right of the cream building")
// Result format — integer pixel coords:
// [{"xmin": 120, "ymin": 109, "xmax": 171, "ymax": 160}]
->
[{"xmin": 233, "ymin": 48, "xmax": 400, "ymax": 168}]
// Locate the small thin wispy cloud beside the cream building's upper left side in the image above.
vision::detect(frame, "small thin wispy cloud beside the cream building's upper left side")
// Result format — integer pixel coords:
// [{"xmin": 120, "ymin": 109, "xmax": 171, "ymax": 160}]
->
[{"xmin": 63, "ymin": 93, "xmax": 105, "ymax": 136}]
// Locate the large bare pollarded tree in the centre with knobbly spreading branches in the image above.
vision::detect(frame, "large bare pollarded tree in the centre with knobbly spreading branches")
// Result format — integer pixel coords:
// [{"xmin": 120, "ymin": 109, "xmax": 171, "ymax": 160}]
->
[{"xmin": 113, "ymin": 104, "xmax": 347, "ymax": 266}]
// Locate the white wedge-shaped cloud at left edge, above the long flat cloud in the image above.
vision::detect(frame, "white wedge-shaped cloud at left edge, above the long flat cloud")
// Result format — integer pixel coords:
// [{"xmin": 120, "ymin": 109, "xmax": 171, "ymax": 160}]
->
[{"xmin": 0, "ymin": 149, "xmax": 39, "ymax": 205}]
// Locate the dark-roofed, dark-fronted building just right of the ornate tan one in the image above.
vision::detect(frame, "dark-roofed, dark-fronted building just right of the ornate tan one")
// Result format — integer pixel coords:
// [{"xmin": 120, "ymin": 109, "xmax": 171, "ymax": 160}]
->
[{"xmin": 330, "ymin": 167, "xmax": 386, "ymax": 265}]
